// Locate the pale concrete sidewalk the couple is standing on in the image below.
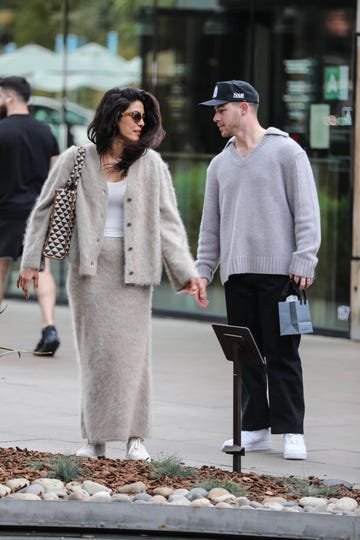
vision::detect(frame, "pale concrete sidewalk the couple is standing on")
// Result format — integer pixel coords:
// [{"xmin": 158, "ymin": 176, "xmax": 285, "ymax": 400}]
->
[{"xmin": 0, "ymin": 300, "xmax": 360, "ymax": 489}]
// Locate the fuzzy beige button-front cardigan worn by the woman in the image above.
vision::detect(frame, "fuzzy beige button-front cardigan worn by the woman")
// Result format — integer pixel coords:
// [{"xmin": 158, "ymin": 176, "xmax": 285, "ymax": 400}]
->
[{"xmin": 21, "ymin": 144, "xmax": 198, "ymax": 290}]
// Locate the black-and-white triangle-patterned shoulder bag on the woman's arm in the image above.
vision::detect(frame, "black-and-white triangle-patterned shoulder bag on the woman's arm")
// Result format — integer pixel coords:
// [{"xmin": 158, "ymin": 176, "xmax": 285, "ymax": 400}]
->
[{"xmin": 43, "ymin": 146, "xmax": 85, "ymax": 261}]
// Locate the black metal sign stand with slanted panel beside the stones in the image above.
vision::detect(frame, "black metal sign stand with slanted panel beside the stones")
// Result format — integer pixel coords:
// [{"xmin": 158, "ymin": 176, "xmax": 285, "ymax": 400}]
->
[{"xmin": 212, "ymin": 324, "xmax": 265, "ymax": 472}]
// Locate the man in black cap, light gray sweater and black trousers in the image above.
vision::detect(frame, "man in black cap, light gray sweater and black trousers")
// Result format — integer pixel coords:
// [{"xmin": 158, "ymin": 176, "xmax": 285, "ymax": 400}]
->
[{"xmin": 196, "ymin": 80, "xmax": 320, "ymax": 459}]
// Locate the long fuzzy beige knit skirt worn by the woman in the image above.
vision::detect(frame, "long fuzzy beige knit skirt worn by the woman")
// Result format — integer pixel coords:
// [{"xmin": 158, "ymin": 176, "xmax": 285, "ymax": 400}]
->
[{"xmin": 67, "ymin": 238, "xmax": 152, "ymax": 443}]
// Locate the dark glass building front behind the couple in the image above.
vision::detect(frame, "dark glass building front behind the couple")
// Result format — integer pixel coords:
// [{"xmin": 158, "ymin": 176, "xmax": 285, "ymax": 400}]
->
[{"xmin": 0, "ymin": 0, "xmax": 360, "ymax": 337}]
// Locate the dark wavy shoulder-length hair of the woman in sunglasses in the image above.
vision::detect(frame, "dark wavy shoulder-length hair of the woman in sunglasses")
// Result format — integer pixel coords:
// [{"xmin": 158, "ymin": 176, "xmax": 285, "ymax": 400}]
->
[{"xmin": 87, "ymin": 86, "xmax": 165, "ymax": 175}]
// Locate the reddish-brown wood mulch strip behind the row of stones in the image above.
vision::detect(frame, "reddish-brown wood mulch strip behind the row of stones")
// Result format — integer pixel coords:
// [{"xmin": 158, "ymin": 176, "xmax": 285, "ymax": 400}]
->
[{"xmin": 0, "ymin": 447, "xmax": 360, "ymax": 504}]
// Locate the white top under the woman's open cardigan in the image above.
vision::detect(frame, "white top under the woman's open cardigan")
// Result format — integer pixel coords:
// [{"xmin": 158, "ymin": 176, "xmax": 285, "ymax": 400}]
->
[{"xmin": 104, "ymin": 179, "xmax": 126, "ymax": 238}]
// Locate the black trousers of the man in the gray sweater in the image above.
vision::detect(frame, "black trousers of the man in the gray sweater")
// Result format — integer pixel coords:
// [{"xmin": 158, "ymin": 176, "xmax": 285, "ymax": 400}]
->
[{"xmin": 225, "ymin": 274, "xmax": 305, "ymax": 433}]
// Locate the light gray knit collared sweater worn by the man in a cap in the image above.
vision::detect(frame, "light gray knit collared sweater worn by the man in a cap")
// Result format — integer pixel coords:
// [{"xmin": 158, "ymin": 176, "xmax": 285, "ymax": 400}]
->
[{"xmin": 196, "ymin": 128, "xmax": 320, "ymax": 283}]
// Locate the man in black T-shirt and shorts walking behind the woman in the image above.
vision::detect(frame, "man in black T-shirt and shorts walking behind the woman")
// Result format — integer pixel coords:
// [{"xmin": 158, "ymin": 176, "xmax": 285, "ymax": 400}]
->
[{"xmin": 0, "ymin": 77, "xmax": 60, "ymax": 355}]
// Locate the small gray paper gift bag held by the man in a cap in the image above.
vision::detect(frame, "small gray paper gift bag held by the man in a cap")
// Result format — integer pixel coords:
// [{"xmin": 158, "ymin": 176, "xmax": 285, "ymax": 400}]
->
[{"xmin": 278, "ymin": 280, "xmax": 313, "ymax": 336}]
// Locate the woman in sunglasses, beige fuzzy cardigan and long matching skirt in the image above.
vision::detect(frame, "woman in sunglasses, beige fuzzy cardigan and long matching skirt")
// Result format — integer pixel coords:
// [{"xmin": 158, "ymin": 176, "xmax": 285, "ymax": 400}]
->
[{"xmin": 17, "ymin": 87, "xmax": 206, "ymax": 461}]
